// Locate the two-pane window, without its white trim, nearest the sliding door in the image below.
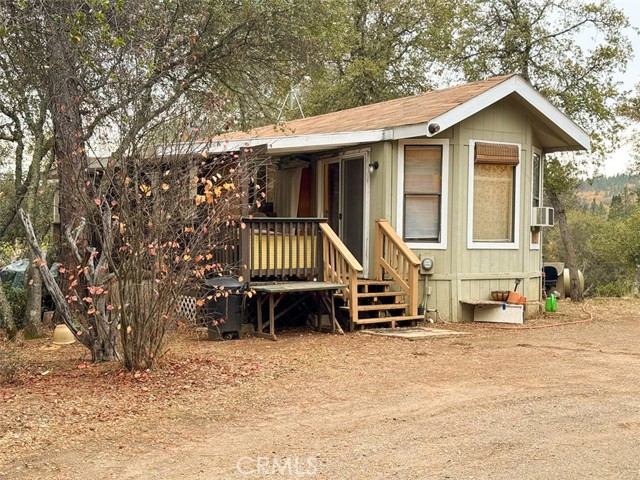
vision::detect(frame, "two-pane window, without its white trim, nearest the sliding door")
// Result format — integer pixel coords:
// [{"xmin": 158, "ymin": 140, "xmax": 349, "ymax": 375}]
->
[{"xmin": 403, "ymin": 145, "xmax": 442, "ymax": 242}]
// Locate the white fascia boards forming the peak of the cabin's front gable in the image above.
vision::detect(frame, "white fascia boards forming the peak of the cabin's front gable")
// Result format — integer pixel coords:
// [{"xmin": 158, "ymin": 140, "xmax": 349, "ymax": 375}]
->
[{"xmin": 423, "ymin": 76, "xmax": 591, "ymax": 150}]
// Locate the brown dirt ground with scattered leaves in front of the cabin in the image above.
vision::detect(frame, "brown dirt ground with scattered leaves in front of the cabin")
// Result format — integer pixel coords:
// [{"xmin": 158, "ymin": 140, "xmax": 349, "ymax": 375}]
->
[{"xmin": 0, "ymin": 299, "xmax": 640, "ymax": 479}]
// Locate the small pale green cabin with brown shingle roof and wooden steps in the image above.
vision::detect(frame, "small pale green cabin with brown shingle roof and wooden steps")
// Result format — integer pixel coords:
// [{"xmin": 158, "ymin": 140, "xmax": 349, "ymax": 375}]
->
[{"xmin": 186, "ymin": 75, "xmax": 590, "ymax": 326}]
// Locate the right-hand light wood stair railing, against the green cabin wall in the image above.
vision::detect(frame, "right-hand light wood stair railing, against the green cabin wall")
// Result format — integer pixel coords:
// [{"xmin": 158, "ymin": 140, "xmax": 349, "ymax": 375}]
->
[{"xmin": 375, "ymin": 219, "xmax": 420, "ymax": 315}]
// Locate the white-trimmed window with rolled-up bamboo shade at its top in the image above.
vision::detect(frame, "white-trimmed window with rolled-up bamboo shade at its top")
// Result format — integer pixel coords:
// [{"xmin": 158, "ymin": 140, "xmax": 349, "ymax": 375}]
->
[{"xmin": 469, "ymin": 141, "xmax": 520, "ymax": 249}]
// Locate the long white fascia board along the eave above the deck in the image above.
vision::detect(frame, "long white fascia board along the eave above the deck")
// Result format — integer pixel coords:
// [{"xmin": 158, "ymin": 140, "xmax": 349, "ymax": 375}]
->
[{"xmin": 156, "ymin": 129, "xmax": 393, "ymax": 156}]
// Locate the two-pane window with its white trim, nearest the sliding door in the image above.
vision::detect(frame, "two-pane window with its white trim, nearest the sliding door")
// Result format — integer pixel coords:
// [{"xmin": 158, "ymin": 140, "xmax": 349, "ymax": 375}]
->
[{"xmin": 398, "ymin": 140, "xmax": 448, "ymax": 249}]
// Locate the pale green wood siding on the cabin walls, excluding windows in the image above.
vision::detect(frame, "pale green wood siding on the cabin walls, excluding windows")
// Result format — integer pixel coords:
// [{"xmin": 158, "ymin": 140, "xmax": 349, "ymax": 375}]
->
[{"xmin": 382, "ymin": 100, "xmax": 542, "ymax": 321}]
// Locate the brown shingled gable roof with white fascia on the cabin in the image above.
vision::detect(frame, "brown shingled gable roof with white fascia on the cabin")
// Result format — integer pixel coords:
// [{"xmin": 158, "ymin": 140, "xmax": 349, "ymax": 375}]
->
[{"xmin": 165, "ymin": 74, "xmax": 590, "ymax": 154}]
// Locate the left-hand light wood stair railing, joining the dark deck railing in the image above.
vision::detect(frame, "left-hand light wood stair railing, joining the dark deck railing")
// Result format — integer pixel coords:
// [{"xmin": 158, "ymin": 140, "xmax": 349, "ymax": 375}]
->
[{"xmin": 320, "ymin": 223, "xmax": 363, "ymax": 322}]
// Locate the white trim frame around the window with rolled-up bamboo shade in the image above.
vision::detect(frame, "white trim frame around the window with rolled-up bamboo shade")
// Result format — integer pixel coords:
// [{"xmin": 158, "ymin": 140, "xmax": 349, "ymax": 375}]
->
[{"xmin": 467, "ymin": 140, "xmax": 522, "ymax": 250}]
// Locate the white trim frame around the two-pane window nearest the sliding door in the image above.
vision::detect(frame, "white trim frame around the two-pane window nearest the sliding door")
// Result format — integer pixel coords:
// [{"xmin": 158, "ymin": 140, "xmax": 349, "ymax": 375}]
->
[{"xmin": 396, "ymin": 138, "xmax": 449, "ymax": 250}]
